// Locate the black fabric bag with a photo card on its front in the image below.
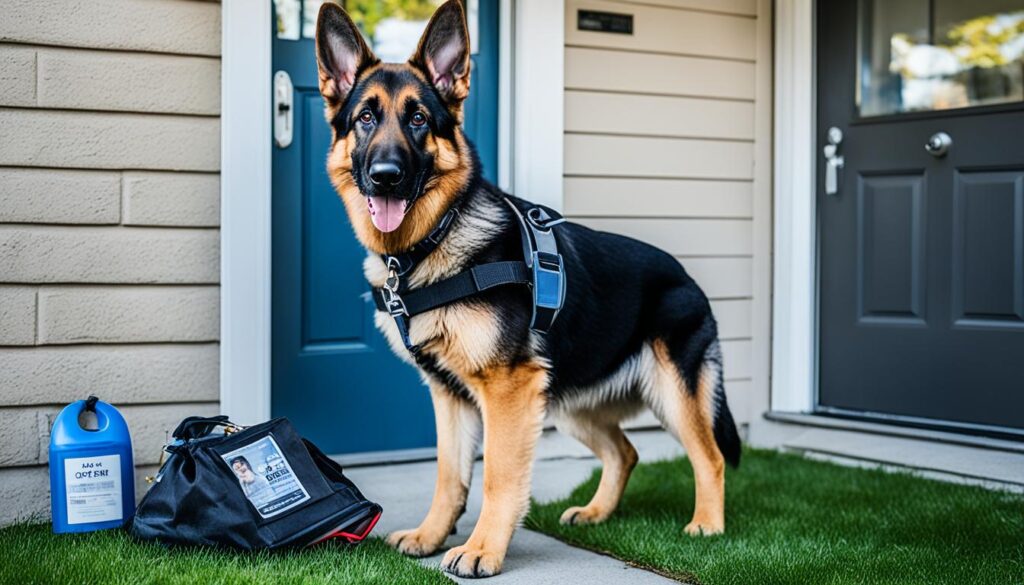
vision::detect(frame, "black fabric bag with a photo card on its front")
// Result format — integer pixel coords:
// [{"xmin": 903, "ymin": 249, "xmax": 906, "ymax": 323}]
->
[{"xmin": 131, "ymin": 416, "xmax": 381, "ymax": 550}]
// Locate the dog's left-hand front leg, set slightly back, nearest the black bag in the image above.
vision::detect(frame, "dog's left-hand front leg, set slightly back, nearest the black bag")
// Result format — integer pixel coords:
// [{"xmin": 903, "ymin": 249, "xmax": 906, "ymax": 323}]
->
[{"xmin": 387, "ymin": 382, "xmax": 480, "ymax": 556}]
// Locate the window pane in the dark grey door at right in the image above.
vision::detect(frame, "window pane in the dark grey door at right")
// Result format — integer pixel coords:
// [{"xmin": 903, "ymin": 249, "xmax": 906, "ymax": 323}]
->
[{"xmin": 857, "ymin": 0, "xmax": 1024, "ymax": 116}]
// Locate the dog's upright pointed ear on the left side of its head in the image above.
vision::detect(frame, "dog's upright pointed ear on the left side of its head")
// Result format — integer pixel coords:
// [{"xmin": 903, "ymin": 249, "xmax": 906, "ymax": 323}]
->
[{"xmin": 316, "ymin": 2, "xmax": 379, "ymax": 112}]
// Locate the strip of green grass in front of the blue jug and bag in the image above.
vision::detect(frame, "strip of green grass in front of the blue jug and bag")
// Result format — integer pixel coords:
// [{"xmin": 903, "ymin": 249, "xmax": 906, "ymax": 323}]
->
[{"xmin": 0, "ymin": 525, "xmax": 452, "ymax": 585}]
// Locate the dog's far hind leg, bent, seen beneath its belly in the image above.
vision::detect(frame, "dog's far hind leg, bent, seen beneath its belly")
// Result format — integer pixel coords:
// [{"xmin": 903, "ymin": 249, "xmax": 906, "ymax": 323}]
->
[{"xmin": 556, "ymin": 411, "xmax": 638, "ymax": 525}]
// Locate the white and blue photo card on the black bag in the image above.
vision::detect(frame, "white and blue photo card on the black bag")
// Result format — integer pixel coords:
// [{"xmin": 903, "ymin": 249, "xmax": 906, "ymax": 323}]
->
[{"xmin": 221, "ymin": 435, "xmax": 309, "ymax": 518}]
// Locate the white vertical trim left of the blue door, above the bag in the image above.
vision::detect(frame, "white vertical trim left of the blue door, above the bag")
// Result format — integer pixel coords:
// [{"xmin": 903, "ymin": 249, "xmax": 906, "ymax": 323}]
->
[{"xmin": 220, "ymin": 0, "xmax": 271, "ymax": 424}]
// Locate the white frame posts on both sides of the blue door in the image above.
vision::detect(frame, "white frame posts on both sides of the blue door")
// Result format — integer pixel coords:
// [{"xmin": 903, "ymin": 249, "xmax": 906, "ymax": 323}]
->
[{"xmin": 220, "ymin": 0, "xmax": 565, "ymax": 424}]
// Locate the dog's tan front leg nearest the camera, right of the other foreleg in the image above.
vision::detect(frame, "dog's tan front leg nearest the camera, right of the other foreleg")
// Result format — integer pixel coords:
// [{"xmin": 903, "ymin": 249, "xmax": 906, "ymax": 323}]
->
[{"xmin": 441, "ymin": 362, "xmax": 548, "ymax": 577}]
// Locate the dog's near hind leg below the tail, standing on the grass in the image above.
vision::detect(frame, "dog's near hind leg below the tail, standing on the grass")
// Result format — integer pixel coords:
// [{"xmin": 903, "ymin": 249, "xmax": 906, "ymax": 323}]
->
[{"xmin": 641, "ymin": 339, "xmax": 738, "ymax": 536}]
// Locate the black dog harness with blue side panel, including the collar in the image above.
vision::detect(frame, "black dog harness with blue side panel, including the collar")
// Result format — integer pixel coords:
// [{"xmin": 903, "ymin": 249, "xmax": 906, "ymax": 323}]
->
[{"xmin": 373, "ymin": 198, "xmax": 565, "ymax": 353}]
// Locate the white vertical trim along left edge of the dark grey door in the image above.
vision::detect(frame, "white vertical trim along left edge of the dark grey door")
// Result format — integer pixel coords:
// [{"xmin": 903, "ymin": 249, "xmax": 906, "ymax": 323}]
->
[{"xmin": 771, "ymin": 0, "xmax": 817, "ymax": 413}]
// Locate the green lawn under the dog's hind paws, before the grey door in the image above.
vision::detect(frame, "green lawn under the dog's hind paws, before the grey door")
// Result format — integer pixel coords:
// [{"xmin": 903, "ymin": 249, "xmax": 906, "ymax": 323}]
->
[{"xmin": 526, "ymin": 450, "xmax": 1024, "ymax": 585}]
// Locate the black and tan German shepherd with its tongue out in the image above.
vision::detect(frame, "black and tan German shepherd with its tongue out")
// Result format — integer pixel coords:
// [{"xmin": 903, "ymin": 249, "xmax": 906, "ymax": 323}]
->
[{"xmin": 316, "ymin": 0, "xmax": 740, "ymax": 577}]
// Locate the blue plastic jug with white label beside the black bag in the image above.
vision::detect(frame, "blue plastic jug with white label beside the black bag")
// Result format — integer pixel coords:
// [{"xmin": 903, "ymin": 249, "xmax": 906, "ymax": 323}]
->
[{"xmin": 50, "ymin": 396, "xmax": 135, "ymax": 533}]
